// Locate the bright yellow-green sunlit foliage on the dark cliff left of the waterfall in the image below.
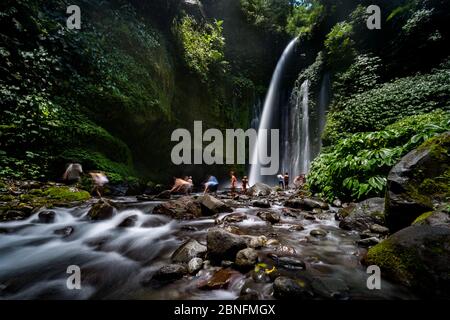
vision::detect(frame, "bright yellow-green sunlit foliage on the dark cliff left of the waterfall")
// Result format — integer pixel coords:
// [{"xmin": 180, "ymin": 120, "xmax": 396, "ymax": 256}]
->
[{"xmin": 175, "ymin": 16, "xmax": 227, "ymax": 81}]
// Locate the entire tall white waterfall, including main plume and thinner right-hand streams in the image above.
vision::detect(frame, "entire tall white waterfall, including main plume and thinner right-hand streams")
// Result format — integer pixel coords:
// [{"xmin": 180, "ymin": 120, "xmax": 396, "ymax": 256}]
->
[{"xmin": 249, "ymin": 39, "xmax": 331, "ymax": 185}]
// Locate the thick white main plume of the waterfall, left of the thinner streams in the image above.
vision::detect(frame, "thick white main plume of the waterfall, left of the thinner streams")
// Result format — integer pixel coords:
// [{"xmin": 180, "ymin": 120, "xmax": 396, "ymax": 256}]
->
[{"xmin": 249, "ymin": 38, "xmax": 297, "ymax": 185}]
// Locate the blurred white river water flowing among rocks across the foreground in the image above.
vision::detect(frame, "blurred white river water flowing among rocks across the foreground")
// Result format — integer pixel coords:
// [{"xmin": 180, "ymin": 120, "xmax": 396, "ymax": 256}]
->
[{"xmin": 0, "ymin": 197, "xmax": 412, "ymax": 299}]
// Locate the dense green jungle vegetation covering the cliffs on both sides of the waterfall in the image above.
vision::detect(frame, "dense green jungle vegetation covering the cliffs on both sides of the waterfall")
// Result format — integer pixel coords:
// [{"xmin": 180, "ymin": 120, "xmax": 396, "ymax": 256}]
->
[{"xmin": 0, "ymin": 0, "xmax": 450, "ymax": 200}]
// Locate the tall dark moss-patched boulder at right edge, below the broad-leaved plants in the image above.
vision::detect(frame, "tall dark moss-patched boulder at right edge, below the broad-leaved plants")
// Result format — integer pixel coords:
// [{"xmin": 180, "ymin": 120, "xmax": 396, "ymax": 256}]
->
[{"xmin": 385, "ymin": 132, "xmax": 450, "ymax": 232}]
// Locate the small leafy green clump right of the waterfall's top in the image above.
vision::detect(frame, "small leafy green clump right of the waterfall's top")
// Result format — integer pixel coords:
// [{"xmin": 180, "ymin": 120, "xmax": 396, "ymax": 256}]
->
[{"xmin": 325, "ymin": 22, "xmax": 356, "ymax": 65}]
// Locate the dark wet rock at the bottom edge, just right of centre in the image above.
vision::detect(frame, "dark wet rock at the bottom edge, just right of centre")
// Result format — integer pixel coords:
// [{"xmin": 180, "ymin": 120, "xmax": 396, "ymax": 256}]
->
[{"xmin": 273, "ymin": 276, "xmax": 313, "ymax": 299}]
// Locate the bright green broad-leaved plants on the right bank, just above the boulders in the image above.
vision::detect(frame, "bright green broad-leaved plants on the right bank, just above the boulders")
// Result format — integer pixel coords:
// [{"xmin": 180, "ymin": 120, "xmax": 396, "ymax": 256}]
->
[{"xmin": 307, "ymin": 111, "xmax": 450, "ymax": 201}]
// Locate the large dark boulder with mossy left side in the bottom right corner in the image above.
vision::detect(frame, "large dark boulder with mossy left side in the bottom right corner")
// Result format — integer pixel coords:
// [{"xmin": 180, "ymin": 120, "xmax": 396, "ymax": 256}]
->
[{"xmin": 365, "ymin": 225, "xmax": 450, "ymax": 299}]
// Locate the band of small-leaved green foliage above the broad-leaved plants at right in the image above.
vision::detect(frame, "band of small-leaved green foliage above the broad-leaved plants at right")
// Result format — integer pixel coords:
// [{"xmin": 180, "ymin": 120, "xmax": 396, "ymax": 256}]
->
[{"xmin": 324, "ymin": 68, "xmax": 450, "ymax": 145}]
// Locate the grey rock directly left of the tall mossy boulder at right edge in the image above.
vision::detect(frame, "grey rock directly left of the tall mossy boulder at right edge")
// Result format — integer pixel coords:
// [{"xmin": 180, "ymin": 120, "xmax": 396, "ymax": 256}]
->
[{"xmin": 339, "ymin": 198, "xmax": 384, "ymax": 232}]
